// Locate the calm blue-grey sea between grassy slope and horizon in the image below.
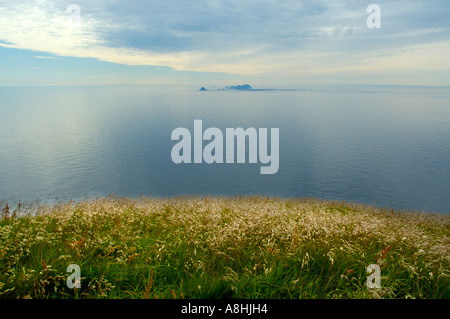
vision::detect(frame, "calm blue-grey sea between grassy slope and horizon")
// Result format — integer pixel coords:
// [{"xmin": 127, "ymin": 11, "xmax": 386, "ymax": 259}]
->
[{"xmin": 0, "ymin": 86, "xmax": 450, "ymax": 213}]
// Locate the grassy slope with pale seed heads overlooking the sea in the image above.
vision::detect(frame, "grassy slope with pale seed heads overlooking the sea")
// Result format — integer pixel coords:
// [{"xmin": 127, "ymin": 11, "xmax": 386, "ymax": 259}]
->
[{"xmin": 0, "ymin": 197, "xmax": 450, "ymax": 299}]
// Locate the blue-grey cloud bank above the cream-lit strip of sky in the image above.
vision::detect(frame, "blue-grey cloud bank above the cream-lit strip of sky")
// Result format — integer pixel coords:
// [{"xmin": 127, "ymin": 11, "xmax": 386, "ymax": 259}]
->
[{"xmin": 82, "ymin": 0, "xmax": 450, "ymax": 56}]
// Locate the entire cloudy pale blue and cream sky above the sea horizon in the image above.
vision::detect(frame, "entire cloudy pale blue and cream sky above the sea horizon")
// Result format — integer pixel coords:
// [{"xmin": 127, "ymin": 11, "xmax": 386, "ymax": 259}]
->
[{"xmin": 0, "ymin": 0, "xmax": 450, "ymax": 87}]
